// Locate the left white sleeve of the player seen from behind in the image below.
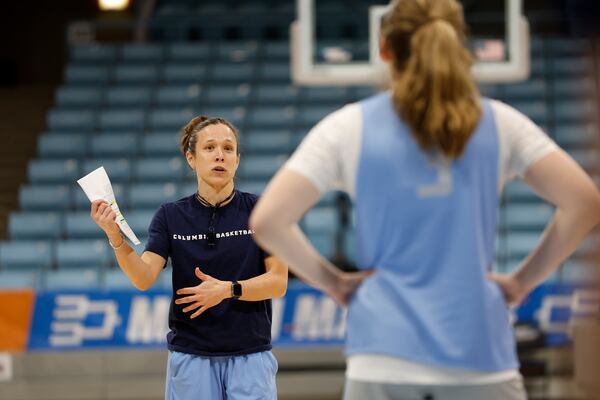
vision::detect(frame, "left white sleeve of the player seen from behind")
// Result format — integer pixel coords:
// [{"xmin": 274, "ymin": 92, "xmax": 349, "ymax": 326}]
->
[{"xmin": 284, "ymin": 103, "xmax": 362, "ymax": 197}]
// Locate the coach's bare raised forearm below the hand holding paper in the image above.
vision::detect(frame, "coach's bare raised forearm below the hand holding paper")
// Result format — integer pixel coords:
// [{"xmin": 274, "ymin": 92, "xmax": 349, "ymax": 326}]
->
[{"xmin": 106, "ymin": 233, "xmax": 156, "ymax": 290}]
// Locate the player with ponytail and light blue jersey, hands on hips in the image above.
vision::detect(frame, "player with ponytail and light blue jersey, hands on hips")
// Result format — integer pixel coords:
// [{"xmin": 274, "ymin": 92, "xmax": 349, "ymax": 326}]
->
[{"xmin": 251, "ymin": 0, "xmax": 600, "ymax": 400}]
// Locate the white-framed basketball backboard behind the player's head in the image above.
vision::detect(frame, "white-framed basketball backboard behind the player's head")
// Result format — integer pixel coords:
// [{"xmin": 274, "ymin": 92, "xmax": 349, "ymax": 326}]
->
[{"xmin": 290, "ymin": 0, "xmax": 530, "ymax": 86}]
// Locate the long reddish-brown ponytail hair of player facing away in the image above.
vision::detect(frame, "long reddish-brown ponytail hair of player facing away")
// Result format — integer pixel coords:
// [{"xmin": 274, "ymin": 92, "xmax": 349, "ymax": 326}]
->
[{"xmin": 381, "ymin": 0, "xmax": 481, "ymax": 159}]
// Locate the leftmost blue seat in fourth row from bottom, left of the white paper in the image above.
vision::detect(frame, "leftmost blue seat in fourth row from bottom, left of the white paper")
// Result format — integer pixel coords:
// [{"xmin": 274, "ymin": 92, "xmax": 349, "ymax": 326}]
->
[{"xmin": 19, "ymin": 185, "xmax": 71, "ymax": 211}]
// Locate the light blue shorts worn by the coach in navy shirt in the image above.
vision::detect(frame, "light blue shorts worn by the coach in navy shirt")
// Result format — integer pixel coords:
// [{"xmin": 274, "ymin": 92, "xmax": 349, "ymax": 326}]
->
[{"xmin": 165, "ymin": 351, "xmax": 277, "ymax": 400}]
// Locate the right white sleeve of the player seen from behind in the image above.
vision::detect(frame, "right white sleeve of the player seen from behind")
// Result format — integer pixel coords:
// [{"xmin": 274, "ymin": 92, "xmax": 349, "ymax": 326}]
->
[{"xmin": 491, "ymin": 100, "xmax": 559, "ymax": 191}]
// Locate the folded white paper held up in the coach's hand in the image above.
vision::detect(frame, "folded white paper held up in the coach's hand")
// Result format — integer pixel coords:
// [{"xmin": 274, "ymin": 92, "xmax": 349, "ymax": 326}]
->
[{"xmin": 77, "ymin": 167, "xmax": 140, "ymax": 245}]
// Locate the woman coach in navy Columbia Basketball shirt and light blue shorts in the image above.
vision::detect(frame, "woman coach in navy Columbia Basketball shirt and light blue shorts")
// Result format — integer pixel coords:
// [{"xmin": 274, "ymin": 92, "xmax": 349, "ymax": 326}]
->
[{"xmin": 91, "ymin": 116, "xmax": 287, "ymax": 400}]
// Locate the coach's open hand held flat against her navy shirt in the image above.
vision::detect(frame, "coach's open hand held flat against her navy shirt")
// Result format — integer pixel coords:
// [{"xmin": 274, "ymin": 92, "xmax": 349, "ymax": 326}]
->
[{"xmin": 175, "ymin": 267, "xmax": 231, "ymax": 319}]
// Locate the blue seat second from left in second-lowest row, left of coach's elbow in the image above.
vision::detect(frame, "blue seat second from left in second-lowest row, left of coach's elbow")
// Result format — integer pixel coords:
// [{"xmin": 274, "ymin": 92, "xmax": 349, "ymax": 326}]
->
[{"xmin": 56, "ymin": 239, "xmax": 114, "ymax": 269}]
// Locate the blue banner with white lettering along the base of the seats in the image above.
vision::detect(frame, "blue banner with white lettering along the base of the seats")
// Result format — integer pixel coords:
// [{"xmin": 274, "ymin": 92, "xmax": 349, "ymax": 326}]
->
[{"xmin": 28, "ymin": 282, "xmax": 600, "ymax": 351}]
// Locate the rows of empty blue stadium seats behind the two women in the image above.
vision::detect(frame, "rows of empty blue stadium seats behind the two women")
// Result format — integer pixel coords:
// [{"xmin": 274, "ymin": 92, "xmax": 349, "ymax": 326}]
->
[{"xmin": 0, "ymin": 34, "xmax": 600, "ymax": 289}]
